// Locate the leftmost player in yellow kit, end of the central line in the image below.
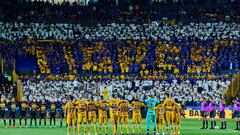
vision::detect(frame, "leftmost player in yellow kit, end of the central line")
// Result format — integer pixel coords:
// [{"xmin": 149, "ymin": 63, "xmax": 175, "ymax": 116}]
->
[{"xmin": 65, "ymin": 96, "xmax": 76, "ymax": 135}]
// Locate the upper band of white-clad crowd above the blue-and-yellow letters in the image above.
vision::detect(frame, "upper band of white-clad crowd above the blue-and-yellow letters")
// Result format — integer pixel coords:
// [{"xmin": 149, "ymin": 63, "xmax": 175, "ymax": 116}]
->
[{"xmin": 0, "ymin": 22, "xmax": 240, "ymax": 41}]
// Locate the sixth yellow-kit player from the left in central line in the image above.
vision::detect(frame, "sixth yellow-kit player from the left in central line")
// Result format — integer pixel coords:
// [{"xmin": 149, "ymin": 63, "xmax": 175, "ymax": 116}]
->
[{"xmin": 119, "ymin": 100, "xmax": 130, "ymax": 135}]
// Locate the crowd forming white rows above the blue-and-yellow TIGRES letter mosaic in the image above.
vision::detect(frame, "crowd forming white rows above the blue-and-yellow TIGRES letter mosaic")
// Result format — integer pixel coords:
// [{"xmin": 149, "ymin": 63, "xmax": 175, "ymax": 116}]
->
[{"xmin": 0, "ymin": 23, "xmax": 240, "ymax": 76}]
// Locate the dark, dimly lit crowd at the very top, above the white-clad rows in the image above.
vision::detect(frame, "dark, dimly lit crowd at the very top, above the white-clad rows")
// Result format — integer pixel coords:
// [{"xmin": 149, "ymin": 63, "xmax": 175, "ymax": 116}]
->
[{"xmin": 1, "ymin": 0, "xmax": 240, "ymax": 24}]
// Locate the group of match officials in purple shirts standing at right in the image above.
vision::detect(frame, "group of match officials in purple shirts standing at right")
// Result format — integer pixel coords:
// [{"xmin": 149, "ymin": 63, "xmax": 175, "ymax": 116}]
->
[{"xmin": 201, "ymin": 97, "xmax": 240, "ymax": 130}]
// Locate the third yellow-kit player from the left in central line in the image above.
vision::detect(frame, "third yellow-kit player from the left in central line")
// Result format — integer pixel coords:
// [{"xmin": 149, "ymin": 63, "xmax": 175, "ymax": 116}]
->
[{"xmin": 87, "ymin": 97, "xmax": 97, "ymax": 135}]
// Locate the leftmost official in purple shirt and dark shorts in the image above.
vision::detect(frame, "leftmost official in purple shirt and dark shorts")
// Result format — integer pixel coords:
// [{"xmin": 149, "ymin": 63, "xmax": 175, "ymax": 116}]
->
[{"xmin": 201, "ymin": 97, "xmax": 208, "ymax": 129}]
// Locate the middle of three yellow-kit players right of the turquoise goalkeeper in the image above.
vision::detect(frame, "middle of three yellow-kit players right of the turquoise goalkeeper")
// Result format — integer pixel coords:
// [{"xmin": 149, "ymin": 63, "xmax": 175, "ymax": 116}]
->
[{"xmin": 163, "ymin": 93, "xmax": 174, "ymax": 134}]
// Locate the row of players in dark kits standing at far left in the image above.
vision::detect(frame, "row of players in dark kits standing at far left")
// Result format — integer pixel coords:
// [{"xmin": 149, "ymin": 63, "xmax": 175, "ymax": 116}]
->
[{"xmin": 0, "ymin": 98, "xmax": 66, "ymax": 127}]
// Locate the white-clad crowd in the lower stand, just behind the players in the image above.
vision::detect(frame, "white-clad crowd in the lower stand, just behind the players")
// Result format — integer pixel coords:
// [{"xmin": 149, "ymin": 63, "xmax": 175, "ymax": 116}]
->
[{"xmin": 22, "ymin": 76, "xmax": 231, "ymax": 106}]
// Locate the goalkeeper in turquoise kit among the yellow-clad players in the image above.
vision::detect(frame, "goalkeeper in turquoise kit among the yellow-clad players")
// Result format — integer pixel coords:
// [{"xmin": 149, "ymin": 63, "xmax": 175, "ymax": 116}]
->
[{"xmin": 144, "ymin": 94, "xmax": 159, "ymax": 135}]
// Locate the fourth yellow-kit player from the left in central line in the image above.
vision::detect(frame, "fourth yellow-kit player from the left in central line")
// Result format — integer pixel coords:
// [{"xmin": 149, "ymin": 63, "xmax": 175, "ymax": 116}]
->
[{"xmin": 98, "ymin": 96, "xmax": 109, "ymax": 135}]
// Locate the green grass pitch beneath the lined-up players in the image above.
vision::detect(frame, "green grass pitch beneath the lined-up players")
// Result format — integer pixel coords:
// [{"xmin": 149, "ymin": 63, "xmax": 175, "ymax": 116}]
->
[{"xmin": 0, "ymin": 119, "xmax": 240, "ymax": 135}]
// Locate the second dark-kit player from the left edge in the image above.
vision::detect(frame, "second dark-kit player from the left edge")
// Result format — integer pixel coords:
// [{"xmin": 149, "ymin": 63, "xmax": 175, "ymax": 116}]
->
[{"xmin": 8, "ymin": 98, "xmax": 17, "ymax": 127}]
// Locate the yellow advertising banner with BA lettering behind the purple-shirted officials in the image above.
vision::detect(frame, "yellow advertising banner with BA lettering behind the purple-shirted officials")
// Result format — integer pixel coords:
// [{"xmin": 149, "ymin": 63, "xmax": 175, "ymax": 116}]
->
[{"xmin": 185, "ymin": 110, "xmax": 232, "ymax": 118}]
